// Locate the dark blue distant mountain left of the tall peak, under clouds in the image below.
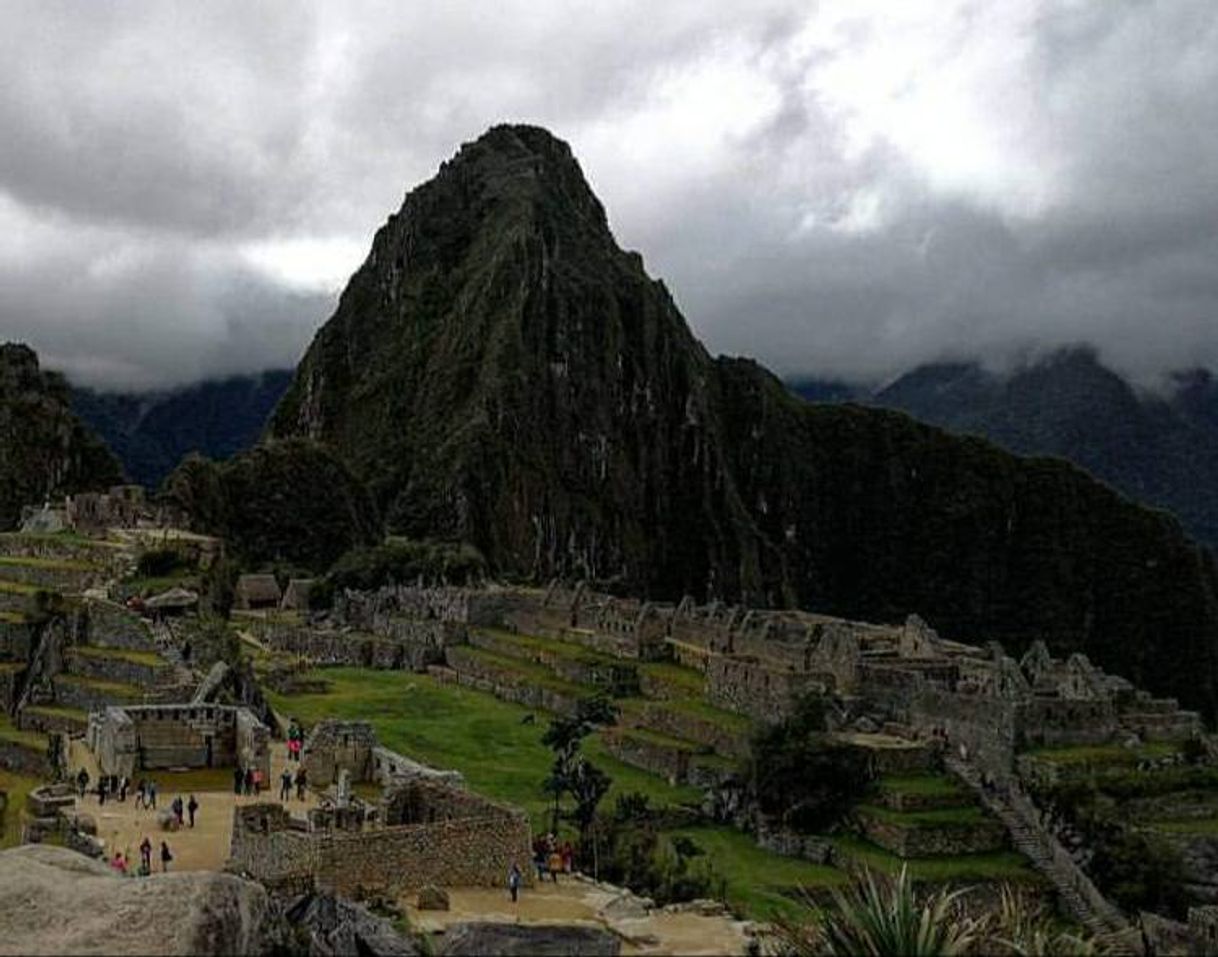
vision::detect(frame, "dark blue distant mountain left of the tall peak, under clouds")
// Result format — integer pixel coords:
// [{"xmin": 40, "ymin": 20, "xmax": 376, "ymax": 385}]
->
[{"xmin": 72, "ymin": 370, "xmax": 292, "ymax": 488}]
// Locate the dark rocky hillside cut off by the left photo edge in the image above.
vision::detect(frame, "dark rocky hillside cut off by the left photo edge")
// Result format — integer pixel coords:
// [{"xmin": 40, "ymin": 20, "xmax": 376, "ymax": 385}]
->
[{"xmin": 0, "ymin": 342, "xmax": 122, "ymax": 531}]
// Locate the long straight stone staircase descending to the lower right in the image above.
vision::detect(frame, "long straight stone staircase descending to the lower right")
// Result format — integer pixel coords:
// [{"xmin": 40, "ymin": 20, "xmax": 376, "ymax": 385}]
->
[{"xmin": 944, "ymin": 756, "xmax": 1130, "ymax": 938}]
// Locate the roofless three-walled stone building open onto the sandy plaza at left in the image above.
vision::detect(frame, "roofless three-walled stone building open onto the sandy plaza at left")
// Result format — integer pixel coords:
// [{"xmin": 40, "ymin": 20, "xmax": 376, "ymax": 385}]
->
[{"xmin": 86, "ymin": 703, "xmax": 270, "ymax": 787}]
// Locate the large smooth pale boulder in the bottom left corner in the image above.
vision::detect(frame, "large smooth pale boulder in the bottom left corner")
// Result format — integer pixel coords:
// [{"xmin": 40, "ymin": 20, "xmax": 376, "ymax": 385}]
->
[{"xmin": 0, "ymin": 845, "xmax": 267, "ymax": 955}]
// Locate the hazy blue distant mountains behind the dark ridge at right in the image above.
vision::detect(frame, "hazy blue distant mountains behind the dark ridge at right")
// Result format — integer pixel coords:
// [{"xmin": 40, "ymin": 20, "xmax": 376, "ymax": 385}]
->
[{"xmin": 792, "ymin": 347, "xmax": 1218, "ymax": 548}]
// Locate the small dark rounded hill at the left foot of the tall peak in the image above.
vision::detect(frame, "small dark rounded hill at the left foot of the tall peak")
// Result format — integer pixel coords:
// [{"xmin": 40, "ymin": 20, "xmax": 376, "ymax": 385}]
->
[{"xmin": 163, "ymin": 440, "xmax": 380, "ymax": 572}]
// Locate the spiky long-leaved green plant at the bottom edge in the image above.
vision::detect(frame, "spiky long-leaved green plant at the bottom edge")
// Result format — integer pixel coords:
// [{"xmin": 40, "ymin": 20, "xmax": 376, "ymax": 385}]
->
[{"xmin": 777, "ymin": 867, "xmax": 982, "ymax": 957}]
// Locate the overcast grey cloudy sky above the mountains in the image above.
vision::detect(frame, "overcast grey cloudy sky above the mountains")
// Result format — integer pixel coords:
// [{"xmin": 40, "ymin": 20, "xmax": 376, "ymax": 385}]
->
[{"xmin": 0, "ymin": 0, "xmax": 1218, "ymax": 387}]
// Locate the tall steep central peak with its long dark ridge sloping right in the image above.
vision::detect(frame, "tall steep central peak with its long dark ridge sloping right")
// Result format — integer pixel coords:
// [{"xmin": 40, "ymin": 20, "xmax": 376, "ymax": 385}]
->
[{"xmin": 269, "ymin": 127, "xmax": 1218, "ymax": 713}]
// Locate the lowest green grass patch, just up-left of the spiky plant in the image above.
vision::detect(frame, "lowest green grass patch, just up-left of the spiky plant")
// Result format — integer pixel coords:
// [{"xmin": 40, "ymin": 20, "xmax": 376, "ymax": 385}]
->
[{"xmin": 672, "ymin": 827, "xmax": 849, "ymax": 920}]
